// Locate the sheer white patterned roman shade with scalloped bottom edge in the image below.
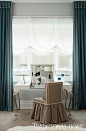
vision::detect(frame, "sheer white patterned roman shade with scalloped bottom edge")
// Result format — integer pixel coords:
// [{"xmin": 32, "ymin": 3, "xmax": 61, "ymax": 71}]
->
[{"xmin": 13, "ymin": 17, "xmax": 73, "ymax": 54}]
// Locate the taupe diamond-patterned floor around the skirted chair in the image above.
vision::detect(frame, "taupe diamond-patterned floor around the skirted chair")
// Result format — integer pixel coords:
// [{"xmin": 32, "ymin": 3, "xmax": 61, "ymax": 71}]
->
[{"xmin": 0, "ymin": 110, "xmax": 86, "ymax": 131}]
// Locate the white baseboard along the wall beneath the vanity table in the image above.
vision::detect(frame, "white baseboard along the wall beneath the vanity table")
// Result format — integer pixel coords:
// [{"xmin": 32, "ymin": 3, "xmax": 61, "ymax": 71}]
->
[{"xmin": 14, "ymin": 100, "xmax": 69, "ymax": 109}]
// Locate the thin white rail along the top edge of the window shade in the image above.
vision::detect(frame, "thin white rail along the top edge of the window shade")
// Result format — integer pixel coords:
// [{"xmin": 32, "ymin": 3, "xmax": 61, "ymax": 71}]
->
[{"xmin": 12, "ymin": 16, "xmax": 73, "ymax": 18}]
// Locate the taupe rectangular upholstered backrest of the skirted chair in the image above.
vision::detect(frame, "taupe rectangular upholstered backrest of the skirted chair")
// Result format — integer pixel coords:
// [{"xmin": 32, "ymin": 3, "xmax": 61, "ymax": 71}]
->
[{"xmin": 45, "ymin": 82, "xmax": 63, "ymax": 104}]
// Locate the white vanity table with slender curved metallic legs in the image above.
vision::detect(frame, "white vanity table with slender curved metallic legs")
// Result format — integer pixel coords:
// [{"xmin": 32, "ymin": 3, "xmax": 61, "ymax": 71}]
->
[{"xmin": 14, "ymin": 81, "xmax": 73, "ymax": 114}]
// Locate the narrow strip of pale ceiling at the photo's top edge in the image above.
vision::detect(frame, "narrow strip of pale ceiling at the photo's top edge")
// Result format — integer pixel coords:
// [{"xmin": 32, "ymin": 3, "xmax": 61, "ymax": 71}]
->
[{"xmin": 0, "ymin": 0, "xmax": 86, "ymax": 3}]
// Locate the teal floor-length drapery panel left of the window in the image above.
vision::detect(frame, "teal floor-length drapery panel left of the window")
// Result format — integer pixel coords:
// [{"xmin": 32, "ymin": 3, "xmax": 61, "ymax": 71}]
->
[{"xmin": 0, "ymin": 1, "xmax": 13, "ymax": 111}]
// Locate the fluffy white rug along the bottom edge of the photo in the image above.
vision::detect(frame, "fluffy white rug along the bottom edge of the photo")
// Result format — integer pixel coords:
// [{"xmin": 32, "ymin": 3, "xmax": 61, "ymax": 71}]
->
[{"xmin": 7, "ymin": 126, "xmax": 86, "ymax": 131}]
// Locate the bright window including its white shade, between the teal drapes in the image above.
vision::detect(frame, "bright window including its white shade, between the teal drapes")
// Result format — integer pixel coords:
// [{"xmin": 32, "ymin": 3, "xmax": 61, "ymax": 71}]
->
[{"xmin": 13, "ymin": 17, "xmax": 73, "ymax": 81}]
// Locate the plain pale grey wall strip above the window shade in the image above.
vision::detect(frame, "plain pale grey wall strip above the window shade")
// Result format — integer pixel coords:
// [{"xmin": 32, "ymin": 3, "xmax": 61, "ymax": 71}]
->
[{"xmin": 13, "ymin": 3, "xmax": 73, "ymax": 16}]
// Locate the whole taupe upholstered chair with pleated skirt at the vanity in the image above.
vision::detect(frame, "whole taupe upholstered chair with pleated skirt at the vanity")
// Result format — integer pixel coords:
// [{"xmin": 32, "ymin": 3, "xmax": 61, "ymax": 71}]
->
[{"xmin": 30, "ymin": 82, "xmax": 67, "ymax": 124}]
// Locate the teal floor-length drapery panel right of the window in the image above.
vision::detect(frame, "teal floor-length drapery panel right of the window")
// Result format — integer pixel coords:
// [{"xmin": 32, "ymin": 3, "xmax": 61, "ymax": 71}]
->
[{"xmin": 72, "ymin": 1, "xmax": 86, "ymax": 110}]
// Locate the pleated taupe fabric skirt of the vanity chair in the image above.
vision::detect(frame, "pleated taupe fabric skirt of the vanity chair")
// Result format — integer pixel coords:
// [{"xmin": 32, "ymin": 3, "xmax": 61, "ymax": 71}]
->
[{"xmin": 30, "ymin": 101, "xmax": 67, "ymax": 124}]
